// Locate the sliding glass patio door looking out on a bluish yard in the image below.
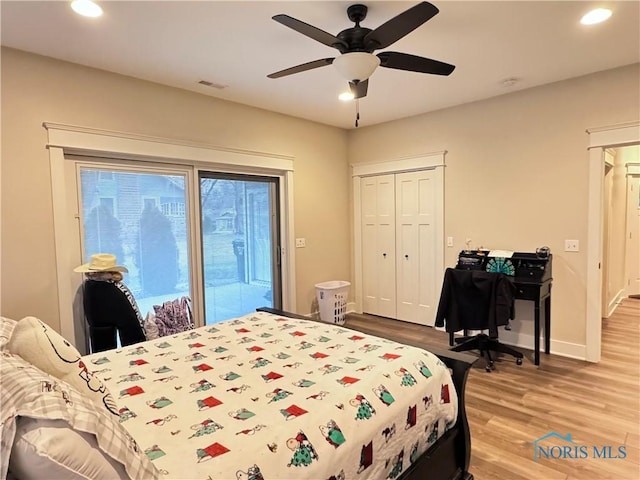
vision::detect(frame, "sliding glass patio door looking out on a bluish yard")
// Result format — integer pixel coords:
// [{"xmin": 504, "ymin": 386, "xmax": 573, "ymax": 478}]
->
[{"xmin": 67, "ymin": 156, "xmax": 282, "ymax": 334}]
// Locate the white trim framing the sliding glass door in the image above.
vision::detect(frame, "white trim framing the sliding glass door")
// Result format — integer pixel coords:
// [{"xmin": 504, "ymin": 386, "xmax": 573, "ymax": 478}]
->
[{"xmin": 43, "ymin": 122, "xmax": 296, "ymax": 344}]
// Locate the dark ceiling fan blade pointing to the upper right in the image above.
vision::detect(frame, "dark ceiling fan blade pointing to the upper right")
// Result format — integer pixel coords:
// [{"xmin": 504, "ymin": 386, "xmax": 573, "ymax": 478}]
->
[{"xmin": 364, "ymin": 2, "xmax": 440, "ymax": 50}]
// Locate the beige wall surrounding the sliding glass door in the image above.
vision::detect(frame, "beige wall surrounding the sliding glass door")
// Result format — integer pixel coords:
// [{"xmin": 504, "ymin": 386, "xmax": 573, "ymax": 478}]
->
[{"xmin": 0, "ymin": 48, "xmax": 350, "ymax": 329}]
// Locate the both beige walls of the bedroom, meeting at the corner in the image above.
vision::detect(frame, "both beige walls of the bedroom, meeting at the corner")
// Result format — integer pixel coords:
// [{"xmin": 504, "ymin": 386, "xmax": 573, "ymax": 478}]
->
[{"xmin": 0, "ymin": 49, "xmax": 640, "ymax": 358}]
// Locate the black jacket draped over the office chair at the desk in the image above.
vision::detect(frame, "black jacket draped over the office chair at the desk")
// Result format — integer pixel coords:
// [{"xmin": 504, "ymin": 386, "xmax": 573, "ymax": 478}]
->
[{"xmin": 436, "ymin": 268, "xmax": 515, "ymax": 338}]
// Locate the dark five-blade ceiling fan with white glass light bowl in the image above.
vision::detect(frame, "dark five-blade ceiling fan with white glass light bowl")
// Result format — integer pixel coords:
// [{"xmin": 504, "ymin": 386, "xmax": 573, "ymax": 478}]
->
[{"xmin": 267, "ymin": 2, "xmax": 456, "ymax": 99}]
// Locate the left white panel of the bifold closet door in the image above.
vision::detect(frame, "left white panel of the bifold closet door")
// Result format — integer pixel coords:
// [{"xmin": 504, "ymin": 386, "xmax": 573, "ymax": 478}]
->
[{"xmin": 361, "ymin": 175, "xmax": 396, "ymax": 318}]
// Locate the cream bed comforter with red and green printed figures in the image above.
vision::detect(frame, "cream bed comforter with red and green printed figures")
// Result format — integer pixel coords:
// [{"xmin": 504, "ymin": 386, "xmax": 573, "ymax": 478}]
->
[{"xmin": 85, "ymin": 312, "xmax": 458, "ymax": 480}]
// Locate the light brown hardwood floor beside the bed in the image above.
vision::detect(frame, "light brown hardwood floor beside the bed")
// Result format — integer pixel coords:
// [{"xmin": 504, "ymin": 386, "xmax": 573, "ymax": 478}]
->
[{"xmin": 345, "ymin": 299, "xmax": 640, "ymax": 480}]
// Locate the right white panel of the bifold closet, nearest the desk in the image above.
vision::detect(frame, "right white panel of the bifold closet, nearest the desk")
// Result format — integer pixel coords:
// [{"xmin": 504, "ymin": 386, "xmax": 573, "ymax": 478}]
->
[{"xmin": 395, "ymin": 170, "xmax": 436, "ymax": 325}]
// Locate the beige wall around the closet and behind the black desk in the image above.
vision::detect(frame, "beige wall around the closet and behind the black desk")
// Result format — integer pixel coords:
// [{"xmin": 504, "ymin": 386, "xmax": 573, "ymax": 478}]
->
[{"xmin": 348, "ymin": 64, "xmax": 640, "ymax": 352}]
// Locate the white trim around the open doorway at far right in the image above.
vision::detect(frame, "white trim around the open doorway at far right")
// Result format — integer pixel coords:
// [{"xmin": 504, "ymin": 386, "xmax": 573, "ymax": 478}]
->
[{"xmin": 586, "ymin": 122, "xmax": 640, "ymax": 363}]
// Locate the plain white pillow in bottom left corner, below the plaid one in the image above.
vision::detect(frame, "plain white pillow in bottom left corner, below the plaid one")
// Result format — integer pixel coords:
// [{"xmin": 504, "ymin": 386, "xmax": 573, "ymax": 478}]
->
[{"xmin": 9, "ymin": 417, "xmax": 127, "ymax": 480}]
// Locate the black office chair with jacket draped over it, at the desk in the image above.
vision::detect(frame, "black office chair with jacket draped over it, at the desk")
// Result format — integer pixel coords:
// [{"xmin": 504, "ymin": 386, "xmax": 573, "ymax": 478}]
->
[{"xmin": 436, "ymin": 268, "xmax": 523, "ymax": 372}]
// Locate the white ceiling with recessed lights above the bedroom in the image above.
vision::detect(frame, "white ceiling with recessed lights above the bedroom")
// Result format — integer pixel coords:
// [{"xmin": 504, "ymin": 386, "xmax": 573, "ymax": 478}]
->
[{"xmin": 0, "ymin": 0, "xmax": 640, "ymax": 128}]
